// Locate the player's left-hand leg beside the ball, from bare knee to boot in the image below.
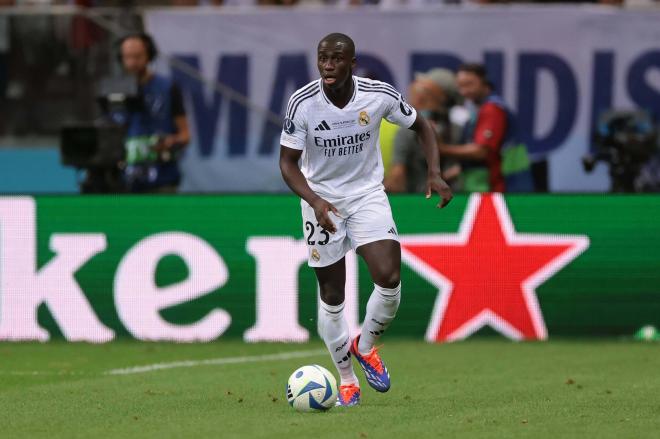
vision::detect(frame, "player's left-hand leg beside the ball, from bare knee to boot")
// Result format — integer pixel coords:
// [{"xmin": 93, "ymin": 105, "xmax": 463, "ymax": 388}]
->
[{"xmin": 314, "ymin": 258, "xmax": 360, "ymax": 406}]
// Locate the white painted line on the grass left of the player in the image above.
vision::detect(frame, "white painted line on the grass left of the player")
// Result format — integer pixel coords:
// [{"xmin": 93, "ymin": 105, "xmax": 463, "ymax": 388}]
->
[{"xmin": 104, "ymin": 349, "xmax": 327, "ymax": 375}]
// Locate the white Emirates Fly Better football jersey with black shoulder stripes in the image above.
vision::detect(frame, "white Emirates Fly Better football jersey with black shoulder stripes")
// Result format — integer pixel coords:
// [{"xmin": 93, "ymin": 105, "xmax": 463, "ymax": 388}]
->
[{"xmin": 280, "ymin": 76, "xmax": 417, "ymax": 200}]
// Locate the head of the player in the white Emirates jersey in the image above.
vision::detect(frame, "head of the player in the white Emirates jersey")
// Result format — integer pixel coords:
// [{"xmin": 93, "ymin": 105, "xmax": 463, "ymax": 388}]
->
[{"xmin": 317, "ymin": 33, "xmax": 355, "ymax": 88}]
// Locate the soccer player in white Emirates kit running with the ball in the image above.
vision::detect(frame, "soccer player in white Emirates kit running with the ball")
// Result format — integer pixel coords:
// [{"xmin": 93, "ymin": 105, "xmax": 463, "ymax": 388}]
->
[{"xmin": 280, "ymin": 33, "xmax": 452, "ymax": 406}]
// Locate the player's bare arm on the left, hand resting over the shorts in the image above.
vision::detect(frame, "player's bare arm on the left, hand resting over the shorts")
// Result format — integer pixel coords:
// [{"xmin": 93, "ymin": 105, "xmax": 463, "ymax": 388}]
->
[{"xmin": 280, "ymin": 145, "xmax": 339, "ymax": 233}]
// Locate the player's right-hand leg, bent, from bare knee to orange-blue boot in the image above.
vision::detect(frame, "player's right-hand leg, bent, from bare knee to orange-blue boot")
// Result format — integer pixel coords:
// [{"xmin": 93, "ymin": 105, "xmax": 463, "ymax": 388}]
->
[{"xmin": 351, "ymin": 239, "xmax": 401, "ymax": 392}]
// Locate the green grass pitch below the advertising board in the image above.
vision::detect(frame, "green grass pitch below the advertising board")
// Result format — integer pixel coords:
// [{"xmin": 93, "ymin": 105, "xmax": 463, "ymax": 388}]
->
[{"xmin": 0, "ymin": 337, "xmax": 660, "ymax": 439}]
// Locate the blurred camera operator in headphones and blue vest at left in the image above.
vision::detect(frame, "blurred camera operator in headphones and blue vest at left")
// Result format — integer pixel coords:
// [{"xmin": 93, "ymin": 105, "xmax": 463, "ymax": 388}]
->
[{"xmin": 112, "ymin": 33, "xmax": 190, "ymax": 193}]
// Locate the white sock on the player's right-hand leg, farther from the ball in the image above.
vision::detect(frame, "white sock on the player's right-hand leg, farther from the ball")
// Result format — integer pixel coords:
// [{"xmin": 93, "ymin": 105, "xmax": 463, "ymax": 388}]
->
[{"xmin": 358, "ymin": 282, "xmax": 401, "ymax": 354}]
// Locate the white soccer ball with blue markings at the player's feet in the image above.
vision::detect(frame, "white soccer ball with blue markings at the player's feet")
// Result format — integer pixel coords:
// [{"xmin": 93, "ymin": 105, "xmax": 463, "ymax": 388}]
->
[{"xmin": 286, "ymin": 364, "xmax": 337, "ymax": 412}]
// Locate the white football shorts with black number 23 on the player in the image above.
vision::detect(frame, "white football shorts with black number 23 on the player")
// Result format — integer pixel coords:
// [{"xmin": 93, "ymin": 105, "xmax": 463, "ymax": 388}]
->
[{"xmin": 300, "ymin": 189, "xmax": 399, "ymax": 267}]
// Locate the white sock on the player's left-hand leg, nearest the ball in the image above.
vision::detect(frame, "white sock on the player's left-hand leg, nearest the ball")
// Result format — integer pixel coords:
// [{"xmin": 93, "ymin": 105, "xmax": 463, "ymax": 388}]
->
[{"xmin": 318, "ymin": 300, "xmax": 359, "ymax": 386}]
